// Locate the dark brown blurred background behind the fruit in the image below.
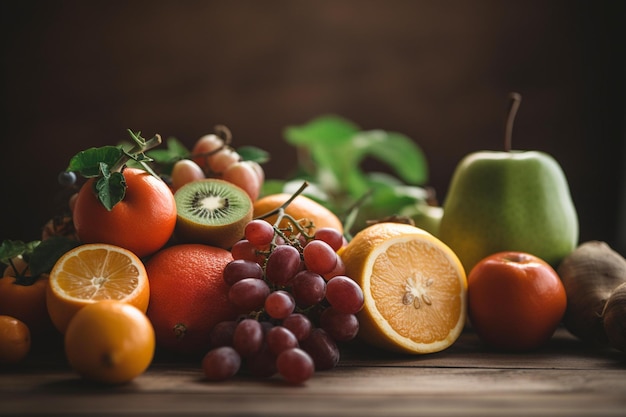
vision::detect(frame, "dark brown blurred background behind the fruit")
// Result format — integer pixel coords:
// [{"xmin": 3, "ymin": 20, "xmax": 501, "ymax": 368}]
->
[{"xmin": 0, "ymin": 0, "xmax": 626, "ymax": 250}]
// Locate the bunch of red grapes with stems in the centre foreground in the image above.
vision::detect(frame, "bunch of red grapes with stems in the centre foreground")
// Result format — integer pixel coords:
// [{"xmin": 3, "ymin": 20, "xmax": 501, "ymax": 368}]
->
[{"xmin": 202, "ymin": 214, "xmax": 363, "ymax": 384}]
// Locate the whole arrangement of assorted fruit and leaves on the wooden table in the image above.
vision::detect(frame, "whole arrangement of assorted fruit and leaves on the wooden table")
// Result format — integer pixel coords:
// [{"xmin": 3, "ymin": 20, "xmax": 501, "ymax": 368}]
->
[{"xmin": 0, "ymin": 94, "xmax": 626, "ymax": 384}]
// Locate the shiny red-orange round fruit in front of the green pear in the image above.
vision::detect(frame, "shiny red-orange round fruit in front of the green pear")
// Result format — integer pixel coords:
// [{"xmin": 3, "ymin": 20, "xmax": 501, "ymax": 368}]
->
[{"xmin": 467, "ymin": 251, "xmax": 567, "ymax": 351}]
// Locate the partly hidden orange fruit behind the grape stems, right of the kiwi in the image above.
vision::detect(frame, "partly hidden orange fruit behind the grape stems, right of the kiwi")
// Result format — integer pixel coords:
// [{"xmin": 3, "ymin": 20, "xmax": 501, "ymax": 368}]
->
[{"xmin": 253, "ymin": 193, "xmax": 343, "ymax": 234}]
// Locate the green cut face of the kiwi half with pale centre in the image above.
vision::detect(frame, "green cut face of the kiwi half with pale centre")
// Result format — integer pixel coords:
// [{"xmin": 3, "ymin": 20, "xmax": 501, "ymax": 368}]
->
[{"xmin": 174, "ymin": 179, "xmax": 252, "ymax": 226}]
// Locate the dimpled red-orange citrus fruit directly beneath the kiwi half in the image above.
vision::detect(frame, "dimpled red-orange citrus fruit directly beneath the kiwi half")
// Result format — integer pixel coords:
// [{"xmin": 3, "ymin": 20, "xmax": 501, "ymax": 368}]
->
[{"xmin": 146, "ymin": 243, "xmax": 237, "ymax": 353}]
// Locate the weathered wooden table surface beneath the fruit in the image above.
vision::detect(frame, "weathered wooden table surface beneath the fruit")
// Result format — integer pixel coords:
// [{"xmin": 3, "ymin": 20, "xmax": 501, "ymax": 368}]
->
[{"xmin": 0, "ymin": 329, "xmax": 626, "ymax": 417}]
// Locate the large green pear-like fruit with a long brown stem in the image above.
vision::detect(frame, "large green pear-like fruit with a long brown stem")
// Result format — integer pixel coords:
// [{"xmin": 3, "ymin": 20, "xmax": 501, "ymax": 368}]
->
[{"xmin": 439, "ymin": 93, "xmax": 579, "ymax": 273}]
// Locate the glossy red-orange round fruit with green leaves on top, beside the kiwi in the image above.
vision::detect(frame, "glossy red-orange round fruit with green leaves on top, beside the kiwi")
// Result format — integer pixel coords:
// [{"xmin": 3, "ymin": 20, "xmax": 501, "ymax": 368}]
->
[{"xmin": 73, "ymin": 168, "xmax": 176, "ymax": 257}]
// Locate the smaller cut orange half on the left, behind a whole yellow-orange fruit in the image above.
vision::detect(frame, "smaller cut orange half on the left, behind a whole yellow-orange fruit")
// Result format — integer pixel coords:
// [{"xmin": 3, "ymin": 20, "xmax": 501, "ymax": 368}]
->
[{"xmin": 46, "ymin": 243, "xmax": 150, "ymax": 333}]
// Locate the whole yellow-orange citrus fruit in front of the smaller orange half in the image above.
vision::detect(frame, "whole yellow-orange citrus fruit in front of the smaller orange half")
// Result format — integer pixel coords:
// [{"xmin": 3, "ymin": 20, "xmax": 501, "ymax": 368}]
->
[{"xmin": 64, "ymin": 300, "xmax": 155, "ymax": 384}]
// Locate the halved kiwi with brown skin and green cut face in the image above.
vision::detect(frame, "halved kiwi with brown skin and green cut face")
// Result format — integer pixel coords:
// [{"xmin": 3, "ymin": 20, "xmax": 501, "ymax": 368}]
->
[{"xmin": 174, "ymin": 178, "xmax": 253, "ymax": 249}]
